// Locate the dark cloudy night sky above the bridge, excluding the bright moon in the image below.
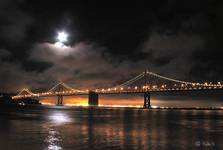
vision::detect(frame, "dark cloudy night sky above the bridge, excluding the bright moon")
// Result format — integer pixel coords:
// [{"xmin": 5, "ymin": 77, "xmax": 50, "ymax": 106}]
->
[{"xmin": 0, "ymin": 0, "xmax": 223, "ymax": 92}]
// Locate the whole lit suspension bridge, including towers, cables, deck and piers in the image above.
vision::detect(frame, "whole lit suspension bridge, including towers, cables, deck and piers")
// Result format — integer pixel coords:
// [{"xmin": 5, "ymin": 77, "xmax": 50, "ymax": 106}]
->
[{"xmin": 12, "ymin": 70, "xmax": 223, "ymax": 108}]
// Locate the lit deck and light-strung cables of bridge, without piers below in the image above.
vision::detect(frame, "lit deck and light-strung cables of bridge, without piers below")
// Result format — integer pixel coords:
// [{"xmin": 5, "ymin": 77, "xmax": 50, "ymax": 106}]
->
[{"xmin": 12, "ymin": 71, "xmax": 223, "ymax": 99}]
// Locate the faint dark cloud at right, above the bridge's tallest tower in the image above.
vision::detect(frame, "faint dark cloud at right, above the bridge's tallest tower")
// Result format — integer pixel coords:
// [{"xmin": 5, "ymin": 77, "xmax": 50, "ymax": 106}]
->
[{"xmin": 141, "ymin": 33, "xmax": 204, "ymax": 78}]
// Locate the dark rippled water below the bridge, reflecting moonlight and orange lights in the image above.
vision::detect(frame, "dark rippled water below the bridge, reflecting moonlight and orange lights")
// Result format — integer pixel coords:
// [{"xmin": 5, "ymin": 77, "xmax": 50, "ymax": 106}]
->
[{"xmin": 0, "ymin": 107, "xmax": 223, "ymax": 150}]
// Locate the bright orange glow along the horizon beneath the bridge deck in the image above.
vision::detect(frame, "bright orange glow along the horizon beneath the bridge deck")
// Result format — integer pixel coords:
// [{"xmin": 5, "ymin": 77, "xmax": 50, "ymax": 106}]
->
[{"xmin": 36, "ymin": 95, "xmax": 223, "ymax": 108}]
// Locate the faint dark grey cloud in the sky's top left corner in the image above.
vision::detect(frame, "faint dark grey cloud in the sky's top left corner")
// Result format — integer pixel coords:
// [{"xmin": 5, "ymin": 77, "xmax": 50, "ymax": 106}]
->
[{"xmin": 0, "ymin": 0, "xmax": 33, "ymax": 44}]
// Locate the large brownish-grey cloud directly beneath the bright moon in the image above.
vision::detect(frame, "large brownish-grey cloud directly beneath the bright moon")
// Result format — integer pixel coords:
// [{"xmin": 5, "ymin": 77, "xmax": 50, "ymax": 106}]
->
[{"xmin": 30, "ymin": 42, "xmax": 145, "ymax": 88}]
